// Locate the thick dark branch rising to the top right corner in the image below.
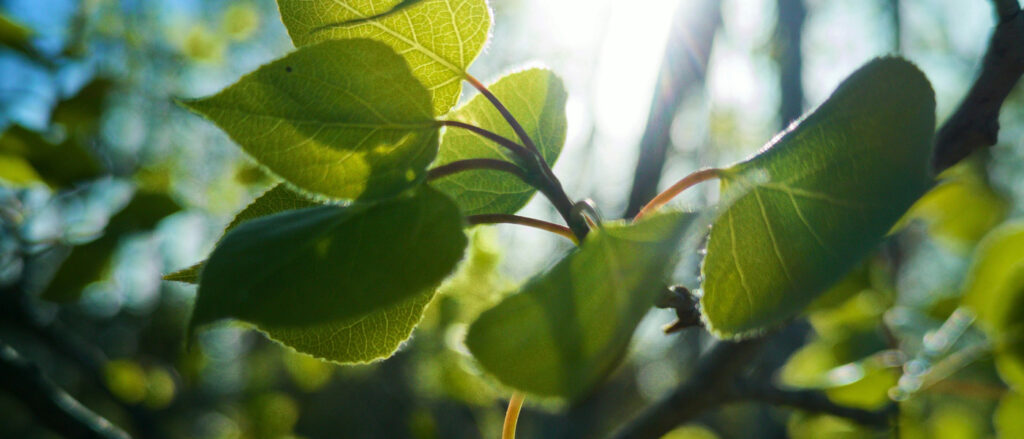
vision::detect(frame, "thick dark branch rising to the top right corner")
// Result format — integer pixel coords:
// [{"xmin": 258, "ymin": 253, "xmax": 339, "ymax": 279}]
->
[{"xmin": 932, "ymin": 0, "xmax": 1024, "ymax": 173}]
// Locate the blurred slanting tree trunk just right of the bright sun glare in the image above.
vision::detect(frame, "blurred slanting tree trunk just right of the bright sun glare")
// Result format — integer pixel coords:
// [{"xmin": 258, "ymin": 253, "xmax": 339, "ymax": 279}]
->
[{"xmin": 624, "ymin": 0, "xmax": 722, "ymax": 218}]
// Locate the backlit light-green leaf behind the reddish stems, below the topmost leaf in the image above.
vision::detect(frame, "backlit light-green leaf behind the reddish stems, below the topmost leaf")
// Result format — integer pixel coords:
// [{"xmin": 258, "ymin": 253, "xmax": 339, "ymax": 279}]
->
[{"xmin": 431, "ymin": 69, "xmax": 567, "ymax": 215}]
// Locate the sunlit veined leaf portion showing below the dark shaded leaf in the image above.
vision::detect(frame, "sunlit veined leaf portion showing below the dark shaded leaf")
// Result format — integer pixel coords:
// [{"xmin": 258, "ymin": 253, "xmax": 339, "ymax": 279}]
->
[{"xmin": 260, "ymin": 289, "xmax": 434, "ymax": 364}]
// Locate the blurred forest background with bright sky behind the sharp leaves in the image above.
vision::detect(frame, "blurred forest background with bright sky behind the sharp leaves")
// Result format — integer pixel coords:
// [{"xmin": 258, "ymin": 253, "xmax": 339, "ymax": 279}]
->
[{"xmin": 0, "ymin": 0, "xmax": 1024, "ymax": 439}]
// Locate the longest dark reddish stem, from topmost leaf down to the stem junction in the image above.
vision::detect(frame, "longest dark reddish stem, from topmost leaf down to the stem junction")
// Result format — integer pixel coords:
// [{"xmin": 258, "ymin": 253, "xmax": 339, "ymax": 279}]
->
[{"xmin": 465, "ymin": 74, "xmax": 590, "ymax": 242}]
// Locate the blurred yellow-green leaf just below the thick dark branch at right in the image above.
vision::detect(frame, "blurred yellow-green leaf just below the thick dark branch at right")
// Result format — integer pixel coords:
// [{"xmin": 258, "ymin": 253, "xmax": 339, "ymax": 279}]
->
[{"xmin": 907, "ymin": 161, "xmax": 1010, "ymax": 250}]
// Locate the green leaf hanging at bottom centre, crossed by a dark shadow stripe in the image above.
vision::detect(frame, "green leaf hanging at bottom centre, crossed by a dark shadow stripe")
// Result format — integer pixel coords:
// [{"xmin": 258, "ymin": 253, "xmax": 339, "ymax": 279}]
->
[{"xmin": 466, "ymin": 213, "xmax": 694, "ymax": 399}]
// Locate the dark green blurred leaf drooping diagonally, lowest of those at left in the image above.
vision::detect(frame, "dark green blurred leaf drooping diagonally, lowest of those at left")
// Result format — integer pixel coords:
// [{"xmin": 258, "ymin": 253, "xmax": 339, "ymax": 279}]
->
[{"xmin": 40, "ymin": 191, "xmax": 181, "ymax": 302}]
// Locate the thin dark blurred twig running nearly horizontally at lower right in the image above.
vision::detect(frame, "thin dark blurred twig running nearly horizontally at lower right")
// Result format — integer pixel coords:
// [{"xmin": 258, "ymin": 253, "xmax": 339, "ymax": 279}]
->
[{"xmin": 737, "ymin": 383, "xmax": 896, "ymax": 428}]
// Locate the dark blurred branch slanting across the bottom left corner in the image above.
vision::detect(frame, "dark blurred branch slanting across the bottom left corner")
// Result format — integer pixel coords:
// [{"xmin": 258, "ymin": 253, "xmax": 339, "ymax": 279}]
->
[{"xmin": 0, "ymin": 343, "xmax": 130, "ymax": 439}]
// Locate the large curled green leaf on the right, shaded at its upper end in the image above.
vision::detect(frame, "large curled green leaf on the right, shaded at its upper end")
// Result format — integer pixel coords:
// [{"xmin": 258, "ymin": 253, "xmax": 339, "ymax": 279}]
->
[{"xmin": 700, "ymin": 57, "xmax": 935, "ymax": 338}]
